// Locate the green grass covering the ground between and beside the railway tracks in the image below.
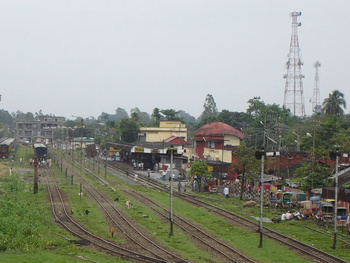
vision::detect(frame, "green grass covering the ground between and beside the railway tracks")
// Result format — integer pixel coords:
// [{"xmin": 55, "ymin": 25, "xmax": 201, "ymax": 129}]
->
[{"xmin": 0, "ymin": 149, "xmax": 350, "ymax": 262}]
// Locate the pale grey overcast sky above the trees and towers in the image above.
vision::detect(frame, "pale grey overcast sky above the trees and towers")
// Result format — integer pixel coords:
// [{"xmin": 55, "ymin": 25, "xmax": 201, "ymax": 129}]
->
[{"xmin": 0, "ymin": 0, "xmax": 350, "ymax": 119}]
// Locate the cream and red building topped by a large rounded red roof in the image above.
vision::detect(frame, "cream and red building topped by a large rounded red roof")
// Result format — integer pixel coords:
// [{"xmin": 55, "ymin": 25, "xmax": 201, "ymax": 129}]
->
[{"xmin": 194, "ymin": 122, "xmax": 244, "ymax": 183}]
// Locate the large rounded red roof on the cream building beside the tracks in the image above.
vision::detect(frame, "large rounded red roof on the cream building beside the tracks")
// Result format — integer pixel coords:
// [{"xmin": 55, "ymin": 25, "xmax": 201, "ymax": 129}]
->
[{"xmin": 194, "ymin": 122, "xmax": 244, "ymax": 140}]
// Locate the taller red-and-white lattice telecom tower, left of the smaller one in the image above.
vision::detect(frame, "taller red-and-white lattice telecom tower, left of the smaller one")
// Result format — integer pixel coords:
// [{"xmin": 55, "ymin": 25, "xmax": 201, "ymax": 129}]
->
[{"xmin": 283, "ymin": 12, "xmax": 305, "ymax": 116}]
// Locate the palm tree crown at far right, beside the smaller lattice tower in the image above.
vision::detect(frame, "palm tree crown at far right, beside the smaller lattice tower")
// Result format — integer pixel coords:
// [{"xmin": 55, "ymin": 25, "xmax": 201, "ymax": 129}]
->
[{"xmin": 322, "ymin": 90, "xmax": 346, "ymax": 116}]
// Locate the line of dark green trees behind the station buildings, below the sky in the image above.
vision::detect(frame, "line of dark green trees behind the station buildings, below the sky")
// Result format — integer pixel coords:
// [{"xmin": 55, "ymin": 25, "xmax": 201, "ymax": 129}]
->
[{"xmin": 0, "ymin": 90, "xmax": 350, "ymax": 190}]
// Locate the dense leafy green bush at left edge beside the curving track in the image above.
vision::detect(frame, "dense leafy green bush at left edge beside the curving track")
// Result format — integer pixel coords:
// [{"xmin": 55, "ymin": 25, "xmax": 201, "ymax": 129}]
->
[{"xmin": 0, "ymin": 175, "xmax": 56, "ymax": 251}]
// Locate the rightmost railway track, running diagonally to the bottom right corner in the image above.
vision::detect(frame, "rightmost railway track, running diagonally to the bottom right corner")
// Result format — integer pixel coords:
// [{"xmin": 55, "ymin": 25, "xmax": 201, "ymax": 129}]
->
[{"xmin": 110, "ymin": 161, "xmax": 347, "ymax": 263}]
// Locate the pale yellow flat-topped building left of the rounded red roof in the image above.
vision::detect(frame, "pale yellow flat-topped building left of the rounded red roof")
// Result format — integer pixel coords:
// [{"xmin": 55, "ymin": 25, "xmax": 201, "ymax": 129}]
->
[{"xmin": 139, "ymin": 120, "xmax": 187, "ymax": 142}]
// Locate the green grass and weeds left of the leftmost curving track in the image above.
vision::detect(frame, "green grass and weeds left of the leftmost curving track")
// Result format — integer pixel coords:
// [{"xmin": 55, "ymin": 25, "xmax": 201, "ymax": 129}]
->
[{"xmin": 0, "ymin": 152, "xmax": 127, "ymax": 263}]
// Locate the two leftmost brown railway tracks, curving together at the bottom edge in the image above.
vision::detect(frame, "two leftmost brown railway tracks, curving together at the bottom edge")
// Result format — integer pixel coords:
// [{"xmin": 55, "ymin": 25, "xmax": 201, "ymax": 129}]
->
[{"xmin": 41, "ymin": 162, "xmax": 187, "ymax": 262}]
